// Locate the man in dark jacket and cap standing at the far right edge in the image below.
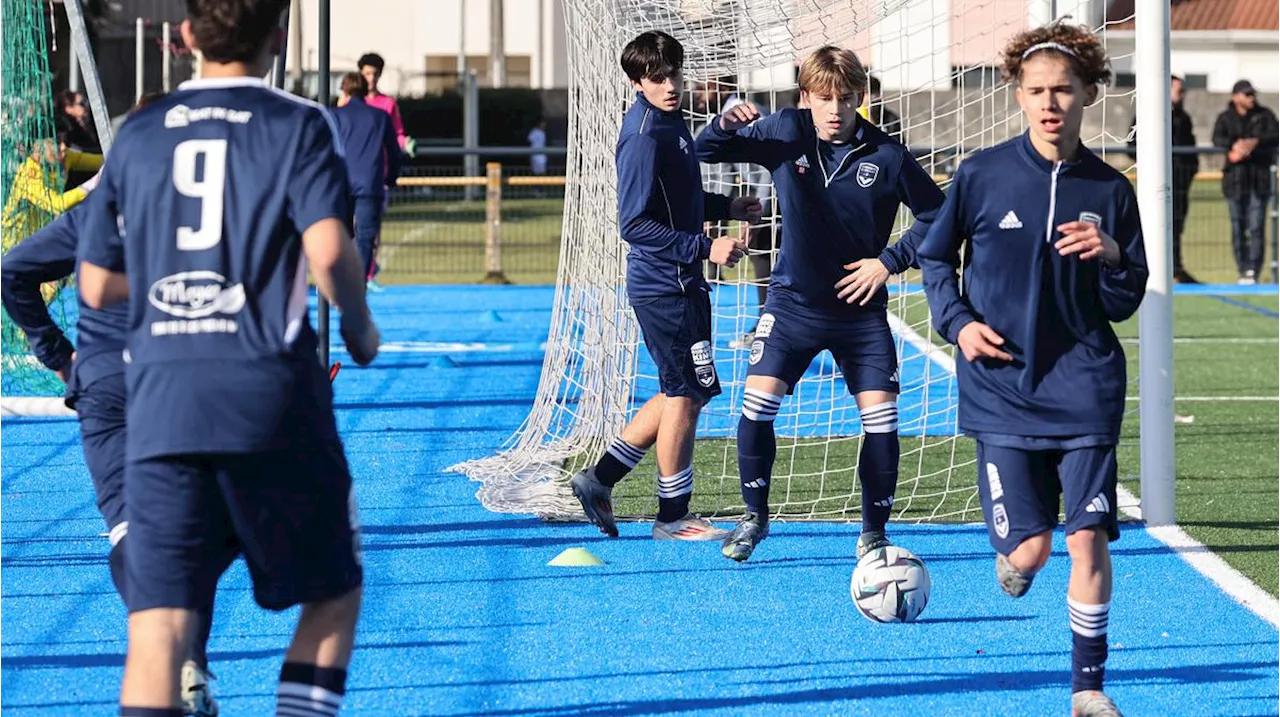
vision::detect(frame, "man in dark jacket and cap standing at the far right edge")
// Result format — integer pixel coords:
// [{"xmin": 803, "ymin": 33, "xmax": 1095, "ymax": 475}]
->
[{"xmin": 1213, "ymin": 79, "xmax": 1280, "ymax": 286}]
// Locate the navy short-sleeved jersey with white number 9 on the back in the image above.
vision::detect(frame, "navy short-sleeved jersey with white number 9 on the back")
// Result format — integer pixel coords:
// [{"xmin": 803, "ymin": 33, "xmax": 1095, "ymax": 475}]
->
[{"xmin": 79, "ymin": 78, "xmax": 349, "ymax": 460}]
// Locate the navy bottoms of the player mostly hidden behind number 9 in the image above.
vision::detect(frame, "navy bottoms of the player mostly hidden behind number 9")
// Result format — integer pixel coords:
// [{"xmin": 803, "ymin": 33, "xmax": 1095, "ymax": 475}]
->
[{"xmin": 74, "ymin": 374, "xmax": 127, "ymax": 530}]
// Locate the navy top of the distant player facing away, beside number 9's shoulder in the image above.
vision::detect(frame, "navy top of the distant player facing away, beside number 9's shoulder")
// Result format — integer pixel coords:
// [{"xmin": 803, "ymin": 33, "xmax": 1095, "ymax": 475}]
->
[{"xmin": 333, "ymin": 97, "xmax": 401, "ymax": 198}]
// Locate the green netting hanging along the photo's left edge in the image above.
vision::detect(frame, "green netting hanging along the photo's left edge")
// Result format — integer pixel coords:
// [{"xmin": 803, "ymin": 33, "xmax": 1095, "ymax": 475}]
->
[{"xmin": 0, "ymin": 0, "xmax": 69, "ymax": 397}]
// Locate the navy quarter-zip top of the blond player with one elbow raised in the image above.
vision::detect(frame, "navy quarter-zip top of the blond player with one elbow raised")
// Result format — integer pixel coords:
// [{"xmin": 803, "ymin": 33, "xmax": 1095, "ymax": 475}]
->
[{"xmin": 698, "ymin": 108, "xmax": 943, "ymax": 316}]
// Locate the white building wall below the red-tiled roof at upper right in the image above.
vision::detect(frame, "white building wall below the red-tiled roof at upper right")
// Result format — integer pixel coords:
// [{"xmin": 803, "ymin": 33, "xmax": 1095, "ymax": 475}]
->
[{"xmin": 1107, "ymin": 31, "xmax": 1280, "ymax": 96}]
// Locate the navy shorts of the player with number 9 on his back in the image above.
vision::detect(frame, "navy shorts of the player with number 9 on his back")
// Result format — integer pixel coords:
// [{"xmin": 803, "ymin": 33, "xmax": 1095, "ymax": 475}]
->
[{"xmin": 124, "ymin": 440, "xmax": 362, "ymax": 612}]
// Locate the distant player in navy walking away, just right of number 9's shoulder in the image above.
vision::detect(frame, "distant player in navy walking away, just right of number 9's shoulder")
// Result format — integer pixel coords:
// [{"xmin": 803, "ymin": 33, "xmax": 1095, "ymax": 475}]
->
[{"xmin": 333, "ymin": 72, "xmax": 401, "ymax": 277}]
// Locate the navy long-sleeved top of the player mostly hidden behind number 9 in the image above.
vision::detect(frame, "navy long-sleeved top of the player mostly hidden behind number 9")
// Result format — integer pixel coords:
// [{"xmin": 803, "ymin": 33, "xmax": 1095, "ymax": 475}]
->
[{"xmin": 0, "ymin": 198, "xmax": 128, "ymax": 385}]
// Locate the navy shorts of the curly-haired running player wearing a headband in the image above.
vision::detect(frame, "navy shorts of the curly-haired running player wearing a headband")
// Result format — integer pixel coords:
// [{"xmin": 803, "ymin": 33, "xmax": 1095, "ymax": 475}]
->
[{"xmin": 978, "ymin": 440, "xmax": 1120, "ymax": 556}]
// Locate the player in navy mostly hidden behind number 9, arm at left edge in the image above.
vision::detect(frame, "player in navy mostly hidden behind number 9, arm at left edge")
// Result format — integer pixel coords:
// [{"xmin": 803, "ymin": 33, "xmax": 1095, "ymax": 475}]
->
[{"xmin": 0, "ymin": 161, "xmax": 222, "ymax": 717}]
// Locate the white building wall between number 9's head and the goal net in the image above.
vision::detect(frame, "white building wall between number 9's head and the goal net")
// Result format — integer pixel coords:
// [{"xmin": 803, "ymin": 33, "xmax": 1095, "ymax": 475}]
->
[{"xmin": 289, "ymin": 0, "xmax": 568, "ymax": 95}]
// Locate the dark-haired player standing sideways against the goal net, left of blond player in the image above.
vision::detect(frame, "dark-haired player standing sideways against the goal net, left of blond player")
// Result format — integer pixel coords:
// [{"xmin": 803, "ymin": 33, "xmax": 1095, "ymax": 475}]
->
[{"xmin": 571, "ymin": 32, "xmax": 760, "ymax": 540}]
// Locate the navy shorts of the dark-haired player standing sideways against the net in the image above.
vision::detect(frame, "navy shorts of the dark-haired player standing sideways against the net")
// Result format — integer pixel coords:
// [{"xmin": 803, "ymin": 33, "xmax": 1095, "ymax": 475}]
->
[{"xmin": 631, "ymin": 289, "xmax": 721, "ymax": 403}]
